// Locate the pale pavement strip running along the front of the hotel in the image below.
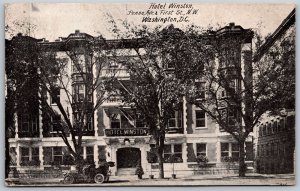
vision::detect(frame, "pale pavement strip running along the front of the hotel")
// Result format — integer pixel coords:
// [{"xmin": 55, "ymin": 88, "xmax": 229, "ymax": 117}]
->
[{"xmin": 6, "ymin": 173, "xmax": 295, "ymax": 186}]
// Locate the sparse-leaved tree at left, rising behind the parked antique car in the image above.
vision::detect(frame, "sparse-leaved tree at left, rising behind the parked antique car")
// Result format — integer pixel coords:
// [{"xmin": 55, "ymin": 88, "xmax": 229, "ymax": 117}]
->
[{"xmin": 36, "ymin": 38, "xmax": 115, "ymax": 170}]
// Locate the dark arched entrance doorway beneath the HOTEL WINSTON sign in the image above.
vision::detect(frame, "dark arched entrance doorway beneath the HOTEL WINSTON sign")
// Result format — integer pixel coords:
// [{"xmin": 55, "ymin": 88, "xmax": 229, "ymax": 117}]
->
[{"xmin": 117, "ymin": 147, "xmax": 141, "ymax": 168}]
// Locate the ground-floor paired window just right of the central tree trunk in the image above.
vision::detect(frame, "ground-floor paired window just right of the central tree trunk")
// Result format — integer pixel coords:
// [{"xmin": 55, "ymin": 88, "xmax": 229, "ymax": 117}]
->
[{"xmin": 164, "ymin": 144, "xmax": 182, "ymax": 163}]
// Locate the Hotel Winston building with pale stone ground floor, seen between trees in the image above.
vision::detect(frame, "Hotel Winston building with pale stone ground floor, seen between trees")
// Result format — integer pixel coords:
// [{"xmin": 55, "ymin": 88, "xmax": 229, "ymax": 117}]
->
[{"xmin": 7, "ymin": 23, "xmax": 253, "ymax": 176}]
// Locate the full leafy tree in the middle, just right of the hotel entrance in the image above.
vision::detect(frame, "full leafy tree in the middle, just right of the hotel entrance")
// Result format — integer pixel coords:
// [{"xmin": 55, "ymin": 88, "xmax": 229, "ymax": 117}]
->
[{"xmin": 107, "ymin": 22, "xmax": 209, "ymax": 178}]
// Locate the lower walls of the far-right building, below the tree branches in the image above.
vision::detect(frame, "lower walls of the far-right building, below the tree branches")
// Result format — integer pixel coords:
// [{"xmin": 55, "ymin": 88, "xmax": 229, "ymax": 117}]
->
[{"xmin": 255, "ymin": 111, "xmax": 295, "ymax": 174}]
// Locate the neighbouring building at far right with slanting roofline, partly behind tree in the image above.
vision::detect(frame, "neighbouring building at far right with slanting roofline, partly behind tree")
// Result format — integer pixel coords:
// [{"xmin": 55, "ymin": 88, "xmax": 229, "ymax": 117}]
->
[{"xmin": 254, "ymin": 9, "xmax": 296, "ymax": 174}]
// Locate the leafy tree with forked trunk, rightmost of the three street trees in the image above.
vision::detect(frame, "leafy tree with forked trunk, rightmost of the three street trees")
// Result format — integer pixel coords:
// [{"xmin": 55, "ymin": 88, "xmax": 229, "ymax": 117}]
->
[{"xmin": 187, "ymin": 25, "xmax": 295, "ymax": 176}]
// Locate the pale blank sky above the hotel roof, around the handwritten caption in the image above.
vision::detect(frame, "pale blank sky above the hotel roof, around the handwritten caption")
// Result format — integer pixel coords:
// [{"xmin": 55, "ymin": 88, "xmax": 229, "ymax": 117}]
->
[{"xmin": 5, "ymin": 3, "xmax": 295, "ymax": 41}]
